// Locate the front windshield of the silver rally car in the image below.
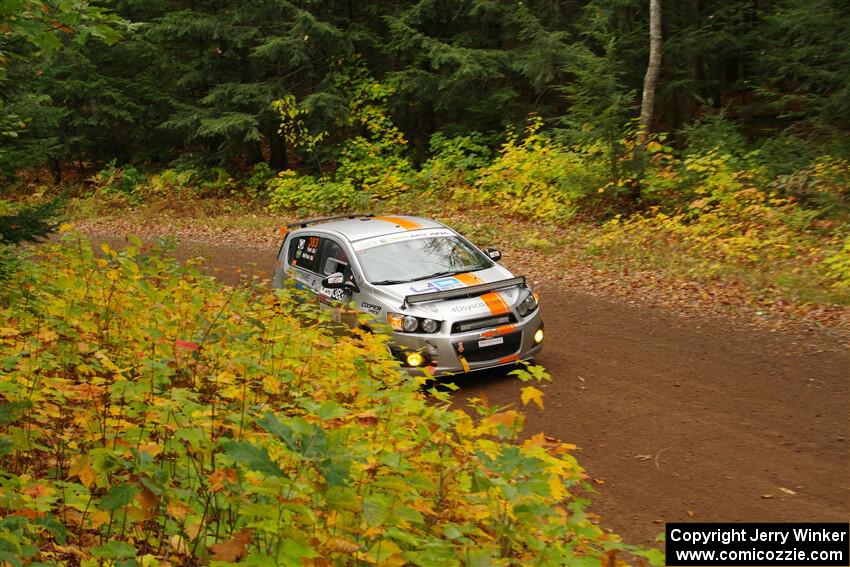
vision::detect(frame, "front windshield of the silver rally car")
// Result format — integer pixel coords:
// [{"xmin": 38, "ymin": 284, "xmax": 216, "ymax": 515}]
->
[{"xmin": 357, "ymin": 236, "xmax": 493, "ymax": 285}]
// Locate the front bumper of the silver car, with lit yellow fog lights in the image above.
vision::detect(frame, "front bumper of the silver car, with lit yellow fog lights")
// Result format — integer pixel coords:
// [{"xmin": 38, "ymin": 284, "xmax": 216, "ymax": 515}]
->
[{"xmin": 391, "ymin": 309, "xmax": 543, "ymax": 376}]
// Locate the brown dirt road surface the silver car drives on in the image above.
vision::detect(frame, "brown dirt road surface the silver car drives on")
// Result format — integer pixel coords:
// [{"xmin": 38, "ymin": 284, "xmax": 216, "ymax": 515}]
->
[{"xmin": 93, "ymin": 234, "xmax": 850, "ymax": 544}]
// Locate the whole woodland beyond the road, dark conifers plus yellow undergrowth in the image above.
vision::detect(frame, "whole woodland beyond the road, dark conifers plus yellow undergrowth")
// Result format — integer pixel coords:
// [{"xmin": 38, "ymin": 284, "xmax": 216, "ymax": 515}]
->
[{"xmin": 0, "ymin": 0, "xmax": 850, "ymax": 304}]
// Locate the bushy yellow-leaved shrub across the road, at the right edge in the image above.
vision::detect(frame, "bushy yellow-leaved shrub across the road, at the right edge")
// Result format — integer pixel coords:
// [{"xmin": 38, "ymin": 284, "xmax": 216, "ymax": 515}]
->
[{"xmin": 593, "ymin": 151, "xmax": 850, "ymax": 303}]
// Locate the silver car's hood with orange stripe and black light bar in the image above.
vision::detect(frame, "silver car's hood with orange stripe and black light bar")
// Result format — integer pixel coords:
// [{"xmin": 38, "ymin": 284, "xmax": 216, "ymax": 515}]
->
[{"xmin": 372, "ymin": 264, "xmax": 522, "ymax": 320}]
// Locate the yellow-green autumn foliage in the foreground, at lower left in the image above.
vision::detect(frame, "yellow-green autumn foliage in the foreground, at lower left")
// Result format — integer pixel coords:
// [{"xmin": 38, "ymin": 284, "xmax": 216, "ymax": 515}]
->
[{"xmin": 0, "ymin": 237, "xmax": 641, "ymax": 566}]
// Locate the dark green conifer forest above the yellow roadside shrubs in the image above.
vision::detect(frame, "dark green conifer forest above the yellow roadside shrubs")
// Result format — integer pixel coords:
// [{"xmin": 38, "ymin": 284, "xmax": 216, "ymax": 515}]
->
[{"xmin": 0, "ymin": 0, "xmax": 850, "ymax": 175}]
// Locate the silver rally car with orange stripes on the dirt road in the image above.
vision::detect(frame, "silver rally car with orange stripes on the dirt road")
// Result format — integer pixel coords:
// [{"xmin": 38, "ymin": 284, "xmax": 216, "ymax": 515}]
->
[{"xmin": 273, "ymin": 215, "xmax": 543, "ymax": 375}]
